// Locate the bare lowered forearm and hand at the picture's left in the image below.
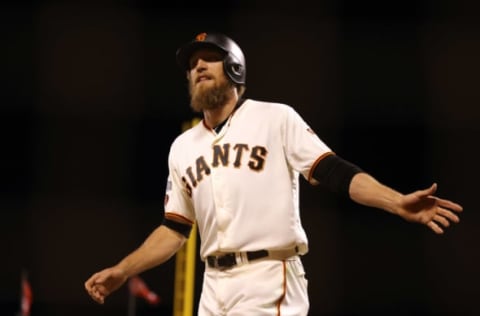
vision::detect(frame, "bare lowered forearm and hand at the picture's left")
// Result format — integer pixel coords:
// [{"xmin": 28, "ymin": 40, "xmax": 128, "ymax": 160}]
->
[{"xmin": 85, "ymin": 225, "xmax": 186, "ymax": 304}]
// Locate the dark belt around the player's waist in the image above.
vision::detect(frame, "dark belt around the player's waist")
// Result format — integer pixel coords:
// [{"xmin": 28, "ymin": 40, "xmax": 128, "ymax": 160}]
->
[{"xmin": 207, "ymin": 246, "xmax": 298, "ymax": 270}]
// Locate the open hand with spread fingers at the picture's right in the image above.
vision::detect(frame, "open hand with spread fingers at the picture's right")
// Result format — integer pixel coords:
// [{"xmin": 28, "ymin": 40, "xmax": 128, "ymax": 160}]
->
[{"xmin": 398, "ymin": 183, "xmax": 463, "ymax": 234}]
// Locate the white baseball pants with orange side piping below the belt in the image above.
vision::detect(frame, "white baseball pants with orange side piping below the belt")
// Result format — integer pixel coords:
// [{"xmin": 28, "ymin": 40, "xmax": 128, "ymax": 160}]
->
[{"xmin": 198, "ymin": 256, "xmax": 309, "ymax": 316}]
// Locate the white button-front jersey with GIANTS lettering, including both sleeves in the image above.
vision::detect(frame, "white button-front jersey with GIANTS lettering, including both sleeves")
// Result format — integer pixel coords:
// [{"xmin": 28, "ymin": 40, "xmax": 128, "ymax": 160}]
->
[{"xmin": 165, "ymin": 99, "xmax": 331, "ymax": 259}]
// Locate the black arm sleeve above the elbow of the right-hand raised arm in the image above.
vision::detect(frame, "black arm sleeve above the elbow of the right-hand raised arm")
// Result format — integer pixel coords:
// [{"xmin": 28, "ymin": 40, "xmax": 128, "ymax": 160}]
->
[{"xmin": 313, "ymin": 155, "xmax": 363, "ymax": 197}]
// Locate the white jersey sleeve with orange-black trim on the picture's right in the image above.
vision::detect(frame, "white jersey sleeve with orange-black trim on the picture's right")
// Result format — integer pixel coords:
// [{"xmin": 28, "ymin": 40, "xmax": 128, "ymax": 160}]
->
[{"xmin": 282, "ymin": 106, "xmax": 333, "ymax": 184}]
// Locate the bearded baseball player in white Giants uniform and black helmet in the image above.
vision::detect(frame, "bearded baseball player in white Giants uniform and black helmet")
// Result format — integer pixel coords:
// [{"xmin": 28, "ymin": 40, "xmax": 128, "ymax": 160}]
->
[{"xmin": 85, "ymin": 33, "xmax": 462, "ymax": 316}]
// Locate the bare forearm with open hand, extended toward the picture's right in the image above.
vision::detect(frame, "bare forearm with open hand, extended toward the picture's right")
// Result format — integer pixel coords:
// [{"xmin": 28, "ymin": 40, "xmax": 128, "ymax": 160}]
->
[{"xmin": 349, "ymin": 172, "xmax": 463, "ymax": 234}]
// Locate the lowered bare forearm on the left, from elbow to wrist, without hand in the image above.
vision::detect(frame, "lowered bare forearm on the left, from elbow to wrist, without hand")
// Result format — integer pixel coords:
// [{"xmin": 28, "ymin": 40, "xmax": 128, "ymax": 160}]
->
[{"xmin": 116, "ymin": 225, "xmax": 186, "ymax": 277}]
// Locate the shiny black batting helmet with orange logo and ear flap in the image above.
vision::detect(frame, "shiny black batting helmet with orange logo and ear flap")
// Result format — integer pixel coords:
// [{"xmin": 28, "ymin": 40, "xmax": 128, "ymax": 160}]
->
[{"xmin": 177, "ymin": 33, "xmax": 247, "ymax": 85}]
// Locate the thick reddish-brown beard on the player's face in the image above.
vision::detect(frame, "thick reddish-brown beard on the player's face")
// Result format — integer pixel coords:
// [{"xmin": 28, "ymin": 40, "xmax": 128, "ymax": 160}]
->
[{"xmin": 188, "ymin": 79, "xmax": 233, "ymax": 112}]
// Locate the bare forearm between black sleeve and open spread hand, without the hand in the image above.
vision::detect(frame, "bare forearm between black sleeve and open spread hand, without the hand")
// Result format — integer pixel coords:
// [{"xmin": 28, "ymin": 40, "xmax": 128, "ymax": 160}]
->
[{"xmin": 349, "ymin": 172, "xmax": 402, "ymax": 215}]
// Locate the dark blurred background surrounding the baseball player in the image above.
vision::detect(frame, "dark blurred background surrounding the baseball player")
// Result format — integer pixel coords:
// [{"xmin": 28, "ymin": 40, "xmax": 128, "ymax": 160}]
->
[{"xmin": 0, "ymin": 0, "xmax": 480, "ymax": 316}]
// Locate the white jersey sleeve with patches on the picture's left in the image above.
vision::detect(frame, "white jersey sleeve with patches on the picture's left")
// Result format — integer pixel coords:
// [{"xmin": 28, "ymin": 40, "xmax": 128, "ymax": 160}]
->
[{"xmin": 164, "ymin": 141, "xmax": 195, "ymax": 224}]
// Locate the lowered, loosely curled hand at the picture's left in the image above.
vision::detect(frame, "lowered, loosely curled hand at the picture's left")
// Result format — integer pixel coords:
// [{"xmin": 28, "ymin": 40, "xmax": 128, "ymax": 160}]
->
[{"xmin": 85, "ymin": 267, "xmax": 127, "ymax": 304}]
